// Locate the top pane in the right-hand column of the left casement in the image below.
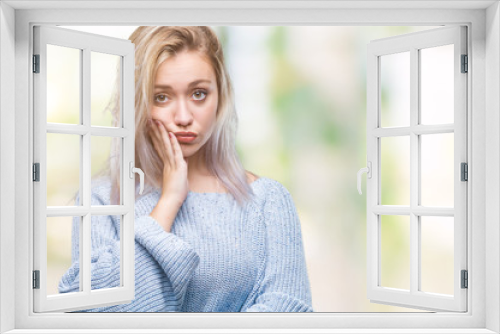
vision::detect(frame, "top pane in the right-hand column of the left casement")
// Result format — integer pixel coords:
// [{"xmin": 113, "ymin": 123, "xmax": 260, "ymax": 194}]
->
[{"xmin": 90, "ymin": 52, "xmax": 121, "ymax": 127}]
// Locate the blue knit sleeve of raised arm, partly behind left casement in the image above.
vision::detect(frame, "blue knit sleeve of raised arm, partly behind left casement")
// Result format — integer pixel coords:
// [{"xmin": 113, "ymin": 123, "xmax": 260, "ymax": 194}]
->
[{"xmin": 59, "ymin": 188, "xmax": 199, "ymax": 312}]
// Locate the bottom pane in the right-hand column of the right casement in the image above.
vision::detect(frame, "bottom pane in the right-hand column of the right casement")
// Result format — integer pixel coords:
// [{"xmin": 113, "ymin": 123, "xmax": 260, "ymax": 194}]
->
[{"xmin": 420, "ymin": 216, "xmax": 454, "ymax": 295}]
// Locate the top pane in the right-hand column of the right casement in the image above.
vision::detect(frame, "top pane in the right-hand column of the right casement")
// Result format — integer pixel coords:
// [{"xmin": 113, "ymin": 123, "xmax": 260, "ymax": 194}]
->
[{"xmin": 420, "ymin": 44, "xmax": 455, "ymax": 124}]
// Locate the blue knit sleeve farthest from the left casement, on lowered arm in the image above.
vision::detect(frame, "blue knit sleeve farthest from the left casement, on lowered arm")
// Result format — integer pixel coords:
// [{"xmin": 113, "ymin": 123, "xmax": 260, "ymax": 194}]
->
[{"xmin": 241, "ymin": 182, "xmax": 313, "ymax": 312}]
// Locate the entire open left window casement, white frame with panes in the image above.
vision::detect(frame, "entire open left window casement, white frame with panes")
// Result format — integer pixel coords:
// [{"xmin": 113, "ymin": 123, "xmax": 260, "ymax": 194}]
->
[{"xmin": 33, "ymin": 26, "xmax": 139, "ymax": 312}]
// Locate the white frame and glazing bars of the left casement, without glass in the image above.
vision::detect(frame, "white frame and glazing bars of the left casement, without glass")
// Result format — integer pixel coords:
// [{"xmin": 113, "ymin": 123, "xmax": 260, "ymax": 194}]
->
[{"xmin": 32, "ymin": 25, "xmax": 135, "ymax": 312}]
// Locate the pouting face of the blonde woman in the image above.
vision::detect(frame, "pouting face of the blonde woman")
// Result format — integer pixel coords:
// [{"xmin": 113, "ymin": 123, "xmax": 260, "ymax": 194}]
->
[{"xmin": 151, "ymin": 52, "xmax": 218, "ymax": 158}]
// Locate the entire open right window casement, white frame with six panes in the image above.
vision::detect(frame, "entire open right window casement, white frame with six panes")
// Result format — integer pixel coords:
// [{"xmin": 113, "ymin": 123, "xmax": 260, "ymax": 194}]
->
[{"xmin": 360, "ymin": 26, "xmax": 468, "ymax": 312}]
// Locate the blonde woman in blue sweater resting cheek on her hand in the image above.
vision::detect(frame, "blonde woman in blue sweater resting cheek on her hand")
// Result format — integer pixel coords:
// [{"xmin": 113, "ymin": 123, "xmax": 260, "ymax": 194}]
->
[{"xmin": 59, "ymin": 26, "xmax": 313, "ymax": 312}]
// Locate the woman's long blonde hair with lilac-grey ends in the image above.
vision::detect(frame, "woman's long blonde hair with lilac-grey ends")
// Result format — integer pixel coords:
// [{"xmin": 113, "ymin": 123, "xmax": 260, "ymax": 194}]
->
[{"xmin": 106, "ymin": 26, "xmax": 253, "ymax": 205}]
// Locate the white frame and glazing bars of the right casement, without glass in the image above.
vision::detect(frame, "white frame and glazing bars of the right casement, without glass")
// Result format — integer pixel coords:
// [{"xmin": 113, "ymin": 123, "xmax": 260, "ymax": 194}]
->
[{"xmin": 366, "ymin": 25, "xmax": 469, "ymax": 312}]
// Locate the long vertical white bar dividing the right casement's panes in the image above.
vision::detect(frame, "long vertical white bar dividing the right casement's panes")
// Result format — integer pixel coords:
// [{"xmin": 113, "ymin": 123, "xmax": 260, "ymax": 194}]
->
[{"xmin": 410, "ymin": 48, "xmax": 420, "ymax": 294}]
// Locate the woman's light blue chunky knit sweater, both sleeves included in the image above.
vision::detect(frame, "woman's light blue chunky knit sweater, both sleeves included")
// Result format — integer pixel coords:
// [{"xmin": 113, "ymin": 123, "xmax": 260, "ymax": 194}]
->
[{"xmin": 59, "ymin": 177, "xmax": 313, "ymax": 312}]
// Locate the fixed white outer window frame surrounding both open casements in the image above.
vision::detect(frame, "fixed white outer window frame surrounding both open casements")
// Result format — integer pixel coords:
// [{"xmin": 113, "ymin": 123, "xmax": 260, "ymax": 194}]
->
[{"xmin": 0, "ymin": 0, "xmax": 500, "ymax": 334}]
